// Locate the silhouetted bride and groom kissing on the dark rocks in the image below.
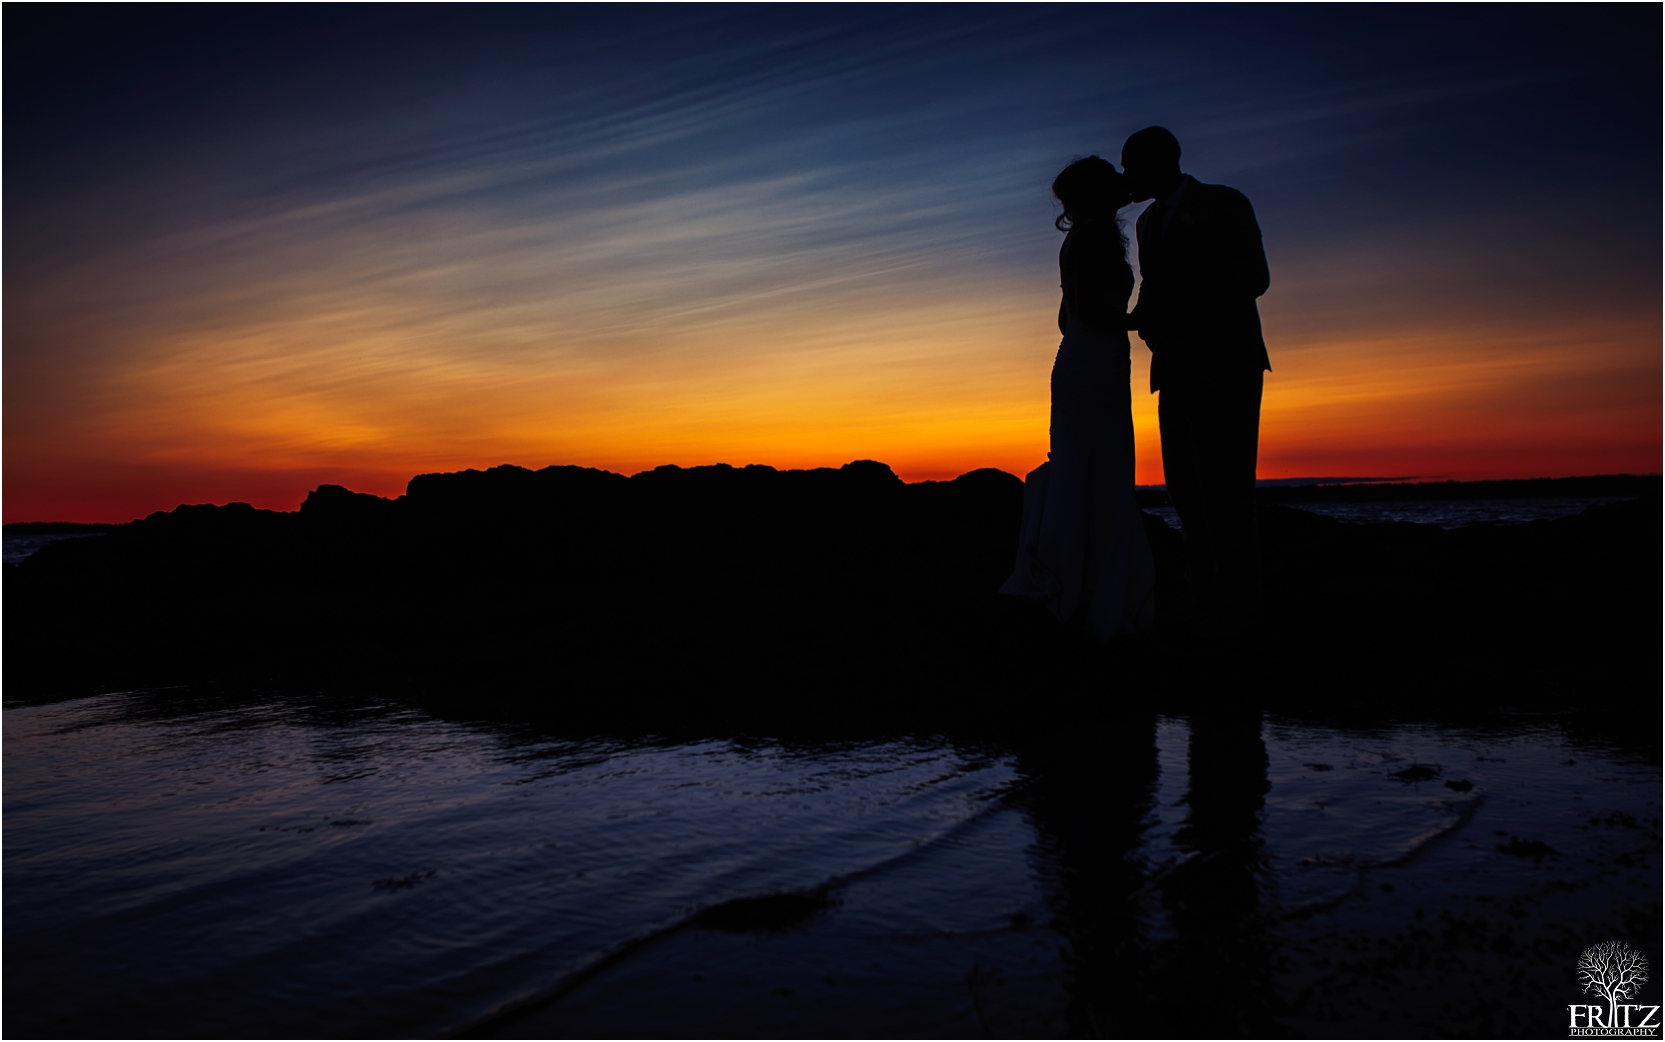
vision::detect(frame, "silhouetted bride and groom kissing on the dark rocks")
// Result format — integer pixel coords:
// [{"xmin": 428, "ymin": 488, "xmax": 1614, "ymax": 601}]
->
[{"xmin": 1002, "ymin": 127, "xmax": 1272, "ymax": 641}]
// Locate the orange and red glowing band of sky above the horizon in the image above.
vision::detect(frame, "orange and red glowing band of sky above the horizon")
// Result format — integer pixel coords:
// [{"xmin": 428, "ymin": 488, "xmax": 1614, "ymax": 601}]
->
[{"xmin": 5, "ymin": 295, "xmax": 1660, "ymax": 521}]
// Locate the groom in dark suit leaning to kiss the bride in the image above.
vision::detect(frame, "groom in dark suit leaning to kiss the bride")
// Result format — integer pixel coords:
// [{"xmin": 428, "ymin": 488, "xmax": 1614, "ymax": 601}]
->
[{"xmin": 1122, "ymin": 127, "xmax": 1272, "ymax": 638}]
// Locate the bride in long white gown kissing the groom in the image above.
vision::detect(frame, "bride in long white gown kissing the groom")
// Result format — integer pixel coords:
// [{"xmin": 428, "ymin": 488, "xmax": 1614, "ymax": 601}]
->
[{"xmin": 1001, "ymin": 155, "xmax": 1156, "ymax": 641}]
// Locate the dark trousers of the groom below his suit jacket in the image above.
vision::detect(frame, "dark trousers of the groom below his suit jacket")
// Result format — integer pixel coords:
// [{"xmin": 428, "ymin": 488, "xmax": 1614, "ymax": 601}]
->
[{"xmin": 1157, "ymin": 371, "xmax": 1264, "ymax": 623}]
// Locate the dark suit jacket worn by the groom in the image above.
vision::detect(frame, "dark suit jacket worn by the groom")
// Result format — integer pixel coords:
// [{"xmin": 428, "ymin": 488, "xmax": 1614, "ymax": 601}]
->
[{"xmin": 1134, "ymin": 175, "xmax": 1272, "ymax": 391}]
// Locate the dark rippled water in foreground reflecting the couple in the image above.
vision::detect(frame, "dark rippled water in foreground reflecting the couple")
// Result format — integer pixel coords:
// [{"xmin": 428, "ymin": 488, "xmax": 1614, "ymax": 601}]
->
[{"xmin": 3, "ymin": 691, "xmax": 1660, "ymax": 1037}]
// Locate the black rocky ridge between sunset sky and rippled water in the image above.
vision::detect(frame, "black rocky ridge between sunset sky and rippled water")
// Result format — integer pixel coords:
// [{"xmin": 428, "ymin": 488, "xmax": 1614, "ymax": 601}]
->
[{"xmin": 5, "ymin": 461, "xmax": 1660, "ymax": 722}]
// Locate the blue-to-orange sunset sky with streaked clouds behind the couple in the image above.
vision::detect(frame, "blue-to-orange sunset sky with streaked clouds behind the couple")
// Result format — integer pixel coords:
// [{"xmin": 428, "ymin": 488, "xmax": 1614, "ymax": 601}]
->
[{"xmin": 3, "ymin": 5, "xmax": 1662, "ymax": 521}]
